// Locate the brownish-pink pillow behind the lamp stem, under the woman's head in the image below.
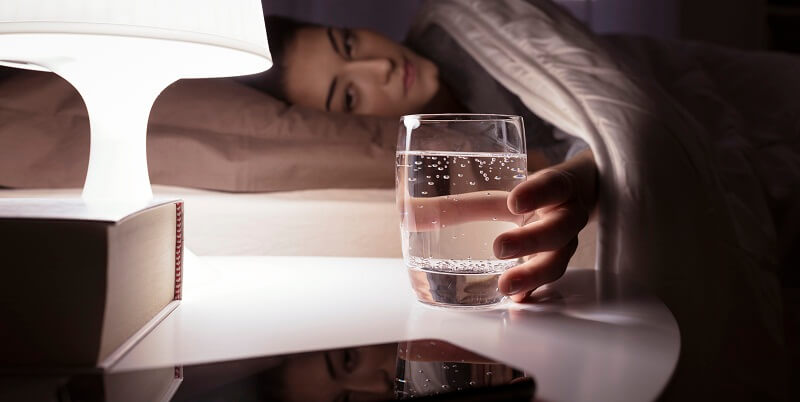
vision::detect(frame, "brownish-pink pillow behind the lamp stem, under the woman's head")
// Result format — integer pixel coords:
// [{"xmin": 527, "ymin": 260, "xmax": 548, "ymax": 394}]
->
[{"xmin": 0, "ymin": 70, "xmax": 398, "ymax": 192}]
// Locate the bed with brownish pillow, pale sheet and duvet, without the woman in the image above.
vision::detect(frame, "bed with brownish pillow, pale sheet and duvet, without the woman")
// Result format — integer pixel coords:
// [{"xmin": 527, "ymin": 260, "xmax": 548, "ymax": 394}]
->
[{"xmin": 0, "ymin": 0, "xmax": 800, "ymax": 399}]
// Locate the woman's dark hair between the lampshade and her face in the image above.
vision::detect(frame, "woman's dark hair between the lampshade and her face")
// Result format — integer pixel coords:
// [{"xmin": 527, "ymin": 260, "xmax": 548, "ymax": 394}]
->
[{"xmin": 239, "ymin": 15, "xmax": 319, "ymax": 102}]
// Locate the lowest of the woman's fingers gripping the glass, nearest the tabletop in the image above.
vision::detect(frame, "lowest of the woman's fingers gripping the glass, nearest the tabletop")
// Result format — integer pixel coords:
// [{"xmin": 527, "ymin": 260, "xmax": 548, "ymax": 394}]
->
[{"xmin": 498, "ymin": 237, "xmax": 578, "ymax": 301}]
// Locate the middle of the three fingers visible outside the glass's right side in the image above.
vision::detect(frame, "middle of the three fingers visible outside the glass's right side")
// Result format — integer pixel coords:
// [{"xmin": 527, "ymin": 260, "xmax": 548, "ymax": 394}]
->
[{"xmin": 494, "ymin": 201, "xmax": 589, "ymax": 259}]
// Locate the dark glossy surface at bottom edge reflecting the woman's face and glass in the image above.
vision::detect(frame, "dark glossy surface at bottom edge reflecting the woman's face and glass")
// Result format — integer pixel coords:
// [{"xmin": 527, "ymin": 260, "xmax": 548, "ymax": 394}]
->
[{"xmin": 0, "ymin": 339, "xmax": 535, "ymax": 402}]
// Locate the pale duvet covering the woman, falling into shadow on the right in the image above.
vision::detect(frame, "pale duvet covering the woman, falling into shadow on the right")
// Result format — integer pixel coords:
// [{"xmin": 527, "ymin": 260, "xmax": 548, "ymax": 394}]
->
[{"xmin": 412, "ymin": 0, "xmax": 800, "ymax": 399}]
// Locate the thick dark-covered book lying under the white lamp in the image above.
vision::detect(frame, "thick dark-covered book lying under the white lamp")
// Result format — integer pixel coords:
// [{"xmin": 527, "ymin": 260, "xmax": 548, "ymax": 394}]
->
[{"xmin": 0, "ymin": 198, "xmax": 183, "ymax": 372}]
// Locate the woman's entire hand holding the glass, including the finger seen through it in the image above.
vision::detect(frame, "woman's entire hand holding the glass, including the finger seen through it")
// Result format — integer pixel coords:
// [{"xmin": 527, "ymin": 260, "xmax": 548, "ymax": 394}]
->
[{"xmin": 397, "ymin": 150, "xmax": 597, "ymax": 301}]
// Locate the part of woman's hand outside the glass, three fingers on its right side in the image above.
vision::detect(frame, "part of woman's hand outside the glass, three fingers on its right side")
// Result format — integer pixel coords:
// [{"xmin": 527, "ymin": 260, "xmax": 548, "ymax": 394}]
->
[{"xmin": 494, "ymin": 150, "xmax": 597, "ymax": 301}]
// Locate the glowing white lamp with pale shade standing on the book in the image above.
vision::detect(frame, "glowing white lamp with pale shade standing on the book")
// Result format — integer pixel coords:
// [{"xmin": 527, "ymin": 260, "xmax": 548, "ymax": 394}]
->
[{"xmin": 0, "ymin": 0, "xmax": 272, "ymax": 204}]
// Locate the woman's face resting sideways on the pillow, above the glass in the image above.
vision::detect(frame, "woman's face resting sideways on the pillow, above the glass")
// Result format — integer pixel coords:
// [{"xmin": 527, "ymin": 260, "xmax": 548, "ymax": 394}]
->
[{"xmin": 285, "ymin": 27, "xmax": 439, "ymax": 117}]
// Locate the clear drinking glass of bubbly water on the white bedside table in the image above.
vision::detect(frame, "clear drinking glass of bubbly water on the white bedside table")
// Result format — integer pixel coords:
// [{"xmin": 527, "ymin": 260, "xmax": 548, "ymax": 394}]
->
[{"xmin": 395, "ymin": 114, "xmax": 528, "ymax": 307}]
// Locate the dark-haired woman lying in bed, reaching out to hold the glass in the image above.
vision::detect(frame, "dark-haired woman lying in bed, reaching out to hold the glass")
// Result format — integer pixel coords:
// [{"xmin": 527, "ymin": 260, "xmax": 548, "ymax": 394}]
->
[{"xmin": 238, "ymin": 17, "xmax": 596, "ymax": 301}]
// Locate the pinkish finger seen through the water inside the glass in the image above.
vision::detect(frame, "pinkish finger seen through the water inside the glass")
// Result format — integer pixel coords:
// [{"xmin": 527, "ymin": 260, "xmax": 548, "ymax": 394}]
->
[{"xmin": 400, "ymin": 190, "xmax": 522, "ymax": 232}]
